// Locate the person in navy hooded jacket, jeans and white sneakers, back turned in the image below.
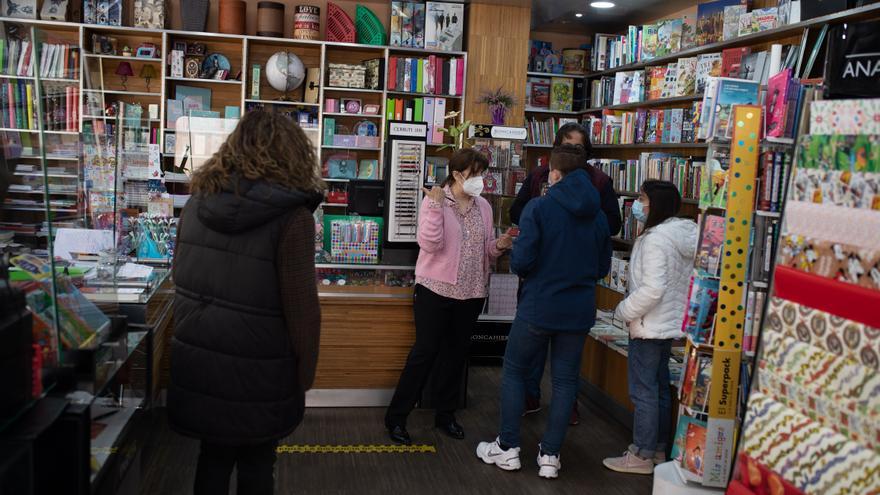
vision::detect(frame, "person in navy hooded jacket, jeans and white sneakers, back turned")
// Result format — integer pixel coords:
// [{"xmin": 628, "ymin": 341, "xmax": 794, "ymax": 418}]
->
[{"xmin": 477, "ymin": 144, "xmax": 611, "ymax": 478}]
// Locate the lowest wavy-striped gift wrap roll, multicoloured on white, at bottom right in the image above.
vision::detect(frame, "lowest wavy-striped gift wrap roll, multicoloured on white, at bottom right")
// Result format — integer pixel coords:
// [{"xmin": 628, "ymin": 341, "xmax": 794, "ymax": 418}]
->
[{"xmin": 742, "ymin": 391, "xmax": 880, "ymax": 495}]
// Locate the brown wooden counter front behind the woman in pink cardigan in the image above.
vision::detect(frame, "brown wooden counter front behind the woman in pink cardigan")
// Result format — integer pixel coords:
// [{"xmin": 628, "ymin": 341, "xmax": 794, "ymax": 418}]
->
[{"xmin": 314, "ymin": 288, "xmax": 416, "ymax": 389}]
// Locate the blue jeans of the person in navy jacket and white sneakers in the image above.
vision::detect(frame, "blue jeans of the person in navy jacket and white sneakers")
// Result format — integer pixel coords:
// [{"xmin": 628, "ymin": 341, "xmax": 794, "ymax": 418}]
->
[{"xmin": 500, "ymin": 319, "xmax": 589, "ymax": 455}]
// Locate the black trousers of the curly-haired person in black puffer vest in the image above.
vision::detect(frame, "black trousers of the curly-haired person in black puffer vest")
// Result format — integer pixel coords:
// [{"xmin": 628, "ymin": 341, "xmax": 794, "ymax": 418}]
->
[{"xmin": 193, "ymin": 440, "xmax": 278, "ymax": 495}]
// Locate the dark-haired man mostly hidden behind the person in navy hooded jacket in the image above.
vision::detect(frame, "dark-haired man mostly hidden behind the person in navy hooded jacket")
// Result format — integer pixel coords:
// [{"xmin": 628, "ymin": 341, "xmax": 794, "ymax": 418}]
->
[{"xmin": 510, "ymin": 123, "xmax": 621, "ymax": 425}]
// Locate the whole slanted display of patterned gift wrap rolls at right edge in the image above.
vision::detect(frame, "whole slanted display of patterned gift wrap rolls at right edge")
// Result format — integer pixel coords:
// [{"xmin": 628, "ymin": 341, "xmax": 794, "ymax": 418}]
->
[{"xmin": 731, "ymin": 99, "xmax": 880, "ymax": 493}]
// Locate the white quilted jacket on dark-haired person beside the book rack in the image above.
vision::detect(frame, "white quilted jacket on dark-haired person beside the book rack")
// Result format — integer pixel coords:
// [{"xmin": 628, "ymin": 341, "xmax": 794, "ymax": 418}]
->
[{"xmin": 616, "ymin": 218, "xmax": 698, "ymax": 339}]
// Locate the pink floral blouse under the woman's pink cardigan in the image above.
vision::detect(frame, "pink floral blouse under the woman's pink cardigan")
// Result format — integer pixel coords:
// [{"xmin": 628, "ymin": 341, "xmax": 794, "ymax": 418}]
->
[{"xmin": 416, "ymin": 201, "xmax": 487, "ymax": 299}]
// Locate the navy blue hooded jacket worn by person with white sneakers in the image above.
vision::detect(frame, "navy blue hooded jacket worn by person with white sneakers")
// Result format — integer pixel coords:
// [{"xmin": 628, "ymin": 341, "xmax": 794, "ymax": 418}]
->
[{"xmin": 510, "ymin": 170, "xmax": 611, "ymax": 333}]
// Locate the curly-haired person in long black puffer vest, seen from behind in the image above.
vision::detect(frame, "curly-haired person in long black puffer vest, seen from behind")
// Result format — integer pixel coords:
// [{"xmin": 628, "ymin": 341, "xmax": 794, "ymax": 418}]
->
[{"xmin": 168, "ymin": 111, "xmax": 324, "ymax": 495}]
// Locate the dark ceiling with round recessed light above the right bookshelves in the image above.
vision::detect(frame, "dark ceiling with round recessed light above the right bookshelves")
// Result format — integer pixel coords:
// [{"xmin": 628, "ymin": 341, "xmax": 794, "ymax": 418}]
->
[{"xmin": 532, "ymin": 0, "xmax": 693, "ymax": 34}]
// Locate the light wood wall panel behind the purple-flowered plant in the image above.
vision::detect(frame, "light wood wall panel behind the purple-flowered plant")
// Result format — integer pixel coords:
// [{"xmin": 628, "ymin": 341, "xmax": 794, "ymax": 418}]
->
[{"xmin": 465, "ymin": 4, "xmax": 531, "ymax": 125}]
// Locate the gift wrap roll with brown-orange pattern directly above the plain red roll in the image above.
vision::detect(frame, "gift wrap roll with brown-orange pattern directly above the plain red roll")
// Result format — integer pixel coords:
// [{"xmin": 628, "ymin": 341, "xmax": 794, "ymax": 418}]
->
[{"xmin": 777, "ymin": 234, "xmax": 880, "ymax": 290}]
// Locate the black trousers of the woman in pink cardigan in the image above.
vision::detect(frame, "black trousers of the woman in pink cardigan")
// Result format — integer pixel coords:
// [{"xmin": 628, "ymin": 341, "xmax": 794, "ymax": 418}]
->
[{"xmin": 385, "ymin": 285, "xmax": 485, "ymax": 427}]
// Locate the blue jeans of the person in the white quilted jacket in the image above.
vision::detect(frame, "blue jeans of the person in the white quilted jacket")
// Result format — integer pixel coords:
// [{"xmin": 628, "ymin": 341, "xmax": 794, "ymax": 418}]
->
[{"xmin": 627, "ymin": 339, "xmax": 672, "ymax": 459}]
